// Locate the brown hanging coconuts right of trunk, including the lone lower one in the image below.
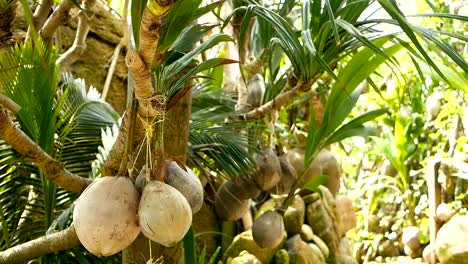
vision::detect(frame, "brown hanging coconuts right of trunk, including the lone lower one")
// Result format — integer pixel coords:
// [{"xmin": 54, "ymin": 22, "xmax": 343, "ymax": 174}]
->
[{"xmin": 215, "ymin": 149, "xmax": 341, "ymax": 248}]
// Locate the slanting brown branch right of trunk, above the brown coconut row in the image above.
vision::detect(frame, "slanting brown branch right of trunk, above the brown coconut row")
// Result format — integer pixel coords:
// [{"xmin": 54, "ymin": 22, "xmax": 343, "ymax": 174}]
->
[{"xmin": 229, "ymin": 74, "xmax": 320, "ymax": 121}]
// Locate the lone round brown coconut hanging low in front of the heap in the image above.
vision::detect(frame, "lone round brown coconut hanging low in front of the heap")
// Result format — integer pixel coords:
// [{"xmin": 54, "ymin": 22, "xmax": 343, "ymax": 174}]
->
[{"xmin": 252, "ymin": 211, "xmax": 285, "ymax": 248}]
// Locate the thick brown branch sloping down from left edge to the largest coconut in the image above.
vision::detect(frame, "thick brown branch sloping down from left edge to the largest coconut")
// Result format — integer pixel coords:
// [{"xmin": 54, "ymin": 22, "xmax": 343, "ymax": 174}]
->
[{"xmin": 0, "ymin": 107, "xmax": 92, "ymax": 193}]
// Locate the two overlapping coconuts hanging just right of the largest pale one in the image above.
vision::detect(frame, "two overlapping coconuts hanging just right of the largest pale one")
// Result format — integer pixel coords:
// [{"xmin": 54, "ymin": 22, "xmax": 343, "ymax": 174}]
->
[{"xmin": 138, "ymin": 161, "xmax": 203, "ymax": 247}]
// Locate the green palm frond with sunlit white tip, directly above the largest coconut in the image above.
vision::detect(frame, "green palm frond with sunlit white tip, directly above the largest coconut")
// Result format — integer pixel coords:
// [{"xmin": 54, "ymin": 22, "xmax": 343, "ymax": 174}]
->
[{"xmin": 57, "ymin": 74, "xmax": 119, "ymax": 177}]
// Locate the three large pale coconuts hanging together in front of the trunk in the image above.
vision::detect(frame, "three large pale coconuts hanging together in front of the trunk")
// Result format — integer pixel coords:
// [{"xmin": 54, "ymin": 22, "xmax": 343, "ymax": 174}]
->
[{"xmin": 73, "ymin": 161, "xmax": 203, "ymax": 257}]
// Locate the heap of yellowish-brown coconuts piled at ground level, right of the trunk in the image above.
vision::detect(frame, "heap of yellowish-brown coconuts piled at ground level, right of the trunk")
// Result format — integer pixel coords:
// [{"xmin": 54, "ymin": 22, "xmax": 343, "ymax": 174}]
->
[{"xmin": 224, "ymin": 186, "xmax": 356, "ymax": 264}]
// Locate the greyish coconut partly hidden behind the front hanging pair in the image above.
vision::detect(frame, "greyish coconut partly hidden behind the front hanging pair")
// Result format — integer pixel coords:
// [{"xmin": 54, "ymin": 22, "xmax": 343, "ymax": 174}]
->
[{"xmin": 165, "ymin": 161, "xmax": 203, "ymax": 214}]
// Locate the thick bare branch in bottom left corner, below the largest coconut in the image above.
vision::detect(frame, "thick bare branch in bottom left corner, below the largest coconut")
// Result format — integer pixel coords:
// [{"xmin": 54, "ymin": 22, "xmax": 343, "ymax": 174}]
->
[{"xmin": 0, "ymin": 225, "xmax": 81, "ymax": 263}]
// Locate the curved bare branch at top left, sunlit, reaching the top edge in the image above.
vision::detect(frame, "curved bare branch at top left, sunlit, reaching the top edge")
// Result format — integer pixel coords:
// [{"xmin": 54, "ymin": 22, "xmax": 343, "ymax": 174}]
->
[{"xmin": 56, "ymin": 0, "xmax": 96, "ymax": 68}]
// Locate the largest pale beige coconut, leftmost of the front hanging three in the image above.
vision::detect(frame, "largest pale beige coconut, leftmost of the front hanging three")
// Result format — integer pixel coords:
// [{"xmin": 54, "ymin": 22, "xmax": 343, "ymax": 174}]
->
[{"xmin": 73, "ymin": 177, "xmax": 140, "ymax": 257}]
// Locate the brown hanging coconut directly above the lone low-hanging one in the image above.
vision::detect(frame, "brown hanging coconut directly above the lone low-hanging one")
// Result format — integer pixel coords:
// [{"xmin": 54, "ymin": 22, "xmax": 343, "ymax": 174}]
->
[{"xmin": 253, "ymin": 149, "xmax": 281, "ymax": 191}]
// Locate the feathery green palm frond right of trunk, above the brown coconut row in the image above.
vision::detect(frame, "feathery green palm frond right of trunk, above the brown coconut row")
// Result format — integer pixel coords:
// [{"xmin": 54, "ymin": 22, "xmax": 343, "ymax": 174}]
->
[{"xmin": 188, "ymin": 80, "xmax": 255, "ymax": 178}]
